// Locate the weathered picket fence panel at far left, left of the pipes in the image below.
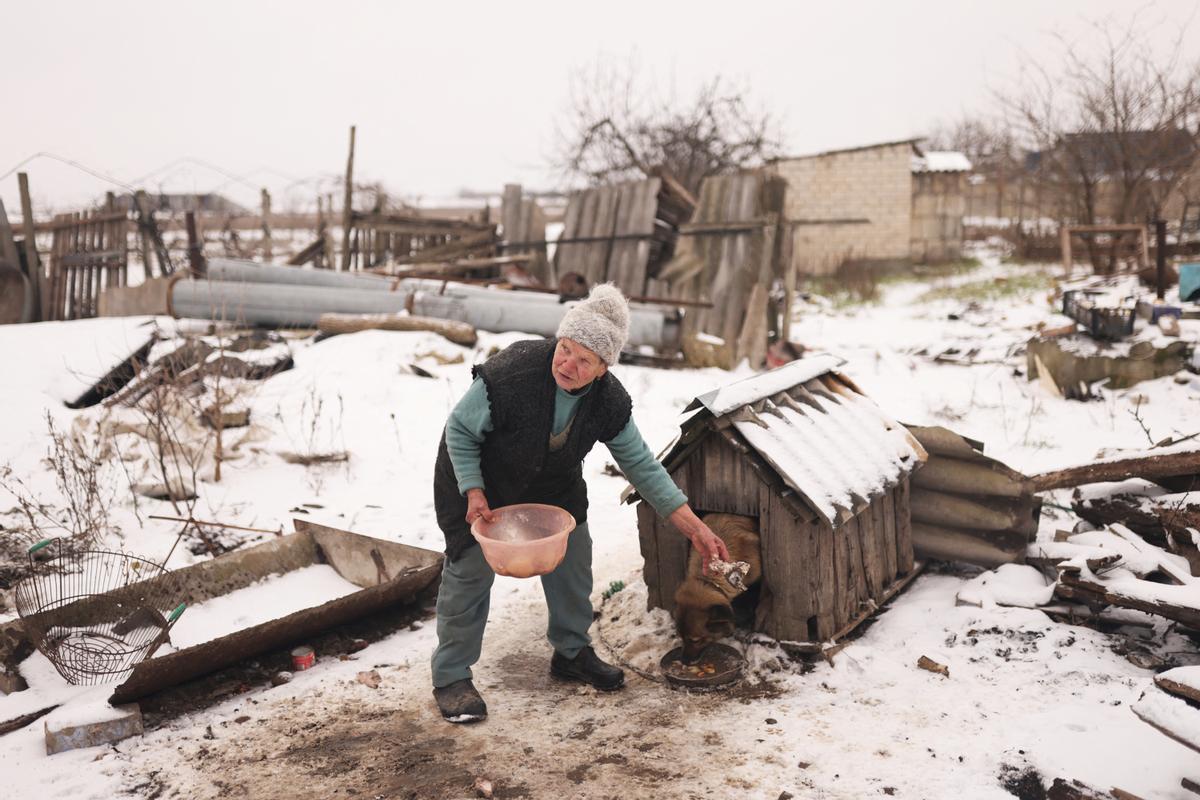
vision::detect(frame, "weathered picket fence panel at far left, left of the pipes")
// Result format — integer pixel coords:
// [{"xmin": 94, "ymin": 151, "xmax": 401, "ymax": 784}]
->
[{"xmin": 42, "ymin": 209, "xmax": 130, "ymax": 320}]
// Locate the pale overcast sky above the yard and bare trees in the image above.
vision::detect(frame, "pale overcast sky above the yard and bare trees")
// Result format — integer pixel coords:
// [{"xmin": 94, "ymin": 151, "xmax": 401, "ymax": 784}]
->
[{"xmin": 0, "ymin": 0, "xmax": 1200, "ymax": 216}]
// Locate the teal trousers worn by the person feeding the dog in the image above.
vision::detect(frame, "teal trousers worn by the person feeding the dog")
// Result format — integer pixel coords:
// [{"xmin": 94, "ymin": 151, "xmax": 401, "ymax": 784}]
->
[{"xmin": 433, "ymin": 522, "xmax": 592, "ymax": 687}]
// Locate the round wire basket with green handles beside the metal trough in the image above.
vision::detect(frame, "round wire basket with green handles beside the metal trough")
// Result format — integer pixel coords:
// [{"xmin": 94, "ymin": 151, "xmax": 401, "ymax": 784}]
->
[{"xmin": 13, "ymin": 539, "xmax": 186, "ymax": 685}]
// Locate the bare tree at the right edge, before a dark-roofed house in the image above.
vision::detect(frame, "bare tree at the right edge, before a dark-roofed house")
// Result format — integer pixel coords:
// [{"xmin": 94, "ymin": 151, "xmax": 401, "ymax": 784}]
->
[{"xmin": 1001, "ymin": 15, "xmax": 1200, "ymax": 271}]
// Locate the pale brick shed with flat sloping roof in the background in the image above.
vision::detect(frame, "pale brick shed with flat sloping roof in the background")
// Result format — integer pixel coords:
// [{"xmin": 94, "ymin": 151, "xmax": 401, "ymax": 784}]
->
[{"xmin": 769, "ymin": 139, "xmax": 971, "ymax": 275}]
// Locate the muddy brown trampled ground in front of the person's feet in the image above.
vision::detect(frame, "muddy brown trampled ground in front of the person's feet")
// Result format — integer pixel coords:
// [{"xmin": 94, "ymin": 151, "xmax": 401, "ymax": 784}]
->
[{"xmin": 119, "ymin": 652, "xmax": 777, "ymax": 799}]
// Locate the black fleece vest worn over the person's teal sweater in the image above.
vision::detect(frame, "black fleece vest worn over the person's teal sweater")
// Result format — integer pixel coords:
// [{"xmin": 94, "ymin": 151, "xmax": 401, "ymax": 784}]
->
[{"xmin": 433, "ymin": 339, "xmax": 632, "ymax": 560}]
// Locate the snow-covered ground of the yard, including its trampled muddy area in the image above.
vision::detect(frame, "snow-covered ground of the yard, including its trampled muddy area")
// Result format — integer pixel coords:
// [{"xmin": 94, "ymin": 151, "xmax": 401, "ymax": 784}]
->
[{"xmin": 0, "ymin": 255, "xmax": 1200, "ymax": 799}]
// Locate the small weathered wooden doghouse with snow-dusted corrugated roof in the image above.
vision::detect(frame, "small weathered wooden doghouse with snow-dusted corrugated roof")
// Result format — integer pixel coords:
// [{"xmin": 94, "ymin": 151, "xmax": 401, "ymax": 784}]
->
[{"xmin": 626, "ymin": 355, "xmax": 926, "ymax": 648}]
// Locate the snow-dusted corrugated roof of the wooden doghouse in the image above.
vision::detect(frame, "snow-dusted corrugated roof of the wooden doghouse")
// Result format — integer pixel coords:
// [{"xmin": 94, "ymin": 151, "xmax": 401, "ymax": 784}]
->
[{"xmin": 638, "ymin": 355, "xmax": 928, "ymax": 528}]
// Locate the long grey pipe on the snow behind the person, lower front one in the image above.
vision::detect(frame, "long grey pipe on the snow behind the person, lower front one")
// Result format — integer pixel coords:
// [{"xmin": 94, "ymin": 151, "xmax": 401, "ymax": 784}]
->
[{"xmin": 168, "ymin": 280, "xmax": 679, "ymax": 350}]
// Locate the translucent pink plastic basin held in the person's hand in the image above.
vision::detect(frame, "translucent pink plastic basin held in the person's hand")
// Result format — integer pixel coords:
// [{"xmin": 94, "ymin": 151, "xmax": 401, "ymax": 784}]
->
[{"xmin": 470, "ymin": 503, "xmax": 575, "ymax": 578}]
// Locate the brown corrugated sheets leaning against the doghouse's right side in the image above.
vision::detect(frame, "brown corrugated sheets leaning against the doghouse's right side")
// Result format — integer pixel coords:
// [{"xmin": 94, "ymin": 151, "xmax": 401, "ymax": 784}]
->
[{"xmin": 908, "ymin": 426, "xmax": 1042, "ymax": 567}]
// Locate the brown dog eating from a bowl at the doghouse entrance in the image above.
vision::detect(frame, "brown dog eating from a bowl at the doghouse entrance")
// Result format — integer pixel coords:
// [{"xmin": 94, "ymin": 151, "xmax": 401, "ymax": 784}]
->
[{"xmin": 674, "ymin": 513, "xmax": 762, "ymax": 663}]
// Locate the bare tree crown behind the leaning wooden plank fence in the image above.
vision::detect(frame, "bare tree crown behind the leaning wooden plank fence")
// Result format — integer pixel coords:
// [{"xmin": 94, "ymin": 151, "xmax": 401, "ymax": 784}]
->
[{"xmin": 553, "ymin": 61, "xmax": 779, "ymax": 193}]
